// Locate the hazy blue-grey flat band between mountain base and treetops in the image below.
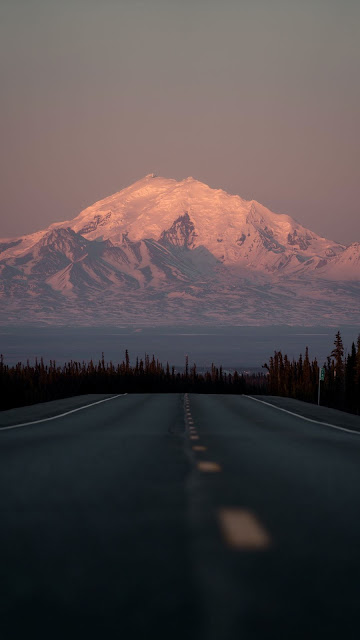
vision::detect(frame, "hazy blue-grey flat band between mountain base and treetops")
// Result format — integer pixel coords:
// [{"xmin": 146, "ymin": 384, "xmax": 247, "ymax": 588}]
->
[{"xmin": 0, "ymin": 325, "xmax": 360, "ymax": 371}]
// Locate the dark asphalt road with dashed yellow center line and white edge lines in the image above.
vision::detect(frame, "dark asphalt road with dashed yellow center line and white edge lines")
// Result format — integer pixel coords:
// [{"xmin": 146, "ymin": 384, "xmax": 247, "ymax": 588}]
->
[{"xmin": 0, "ymin": 394, "xmax": 360, "ymax": 640}]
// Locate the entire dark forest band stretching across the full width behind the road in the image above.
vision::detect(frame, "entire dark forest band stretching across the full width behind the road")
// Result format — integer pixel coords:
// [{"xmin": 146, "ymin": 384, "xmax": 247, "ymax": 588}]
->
[{"xmin": 0, "ymin": 331, "xmax": 360, "ymax": 414}]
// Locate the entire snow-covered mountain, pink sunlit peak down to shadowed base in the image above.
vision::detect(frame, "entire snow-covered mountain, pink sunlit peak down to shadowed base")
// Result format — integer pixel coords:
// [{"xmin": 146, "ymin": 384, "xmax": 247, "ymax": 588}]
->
[{"xmin": 0, "ymin": 174, "xmax": 360, "ymax": 324}]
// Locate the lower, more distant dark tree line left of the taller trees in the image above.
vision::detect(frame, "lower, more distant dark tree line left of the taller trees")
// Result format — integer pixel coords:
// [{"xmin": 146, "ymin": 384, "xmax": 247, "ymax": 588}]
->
[{"xmin": 0, "ymin": 350, "xmax": 267, "ymax": 410}]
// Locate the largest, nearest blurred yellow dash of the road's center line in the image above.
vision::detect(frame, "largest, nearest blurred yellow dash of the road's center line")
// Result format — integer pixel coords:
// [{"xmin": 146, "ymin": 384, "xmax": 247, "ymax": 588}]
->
[{"xmin": 218, "ymin": 508, "xmax": 271, "ymax": 551}]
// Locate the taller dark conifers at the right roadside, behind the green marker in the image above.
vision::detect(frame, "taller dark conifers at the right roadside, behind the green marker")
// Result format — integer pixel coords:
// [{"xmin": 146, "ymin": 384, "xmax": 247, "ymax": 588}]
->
[{"xmin": 263, "ymin": 331, "xmax": 360, "ymax": 414}]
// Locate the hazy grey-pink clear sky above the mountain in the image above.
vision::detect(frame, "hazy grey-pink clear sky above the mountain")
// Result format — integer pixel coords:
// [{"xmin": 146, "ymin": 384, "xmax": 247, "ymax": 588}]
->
[{"xmin": 0, "ymin": 0, "xmax": 360, "ymax": 244}]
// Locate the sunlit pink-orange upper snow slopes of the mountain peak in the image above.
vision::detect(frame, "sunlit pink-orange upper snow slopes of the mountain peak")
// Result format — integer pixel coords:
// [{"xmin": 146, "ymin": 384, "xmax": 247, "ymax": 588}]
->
[{"xmin": 49, "ymin": 175, "xmax": 344, "ymax": 271}]
